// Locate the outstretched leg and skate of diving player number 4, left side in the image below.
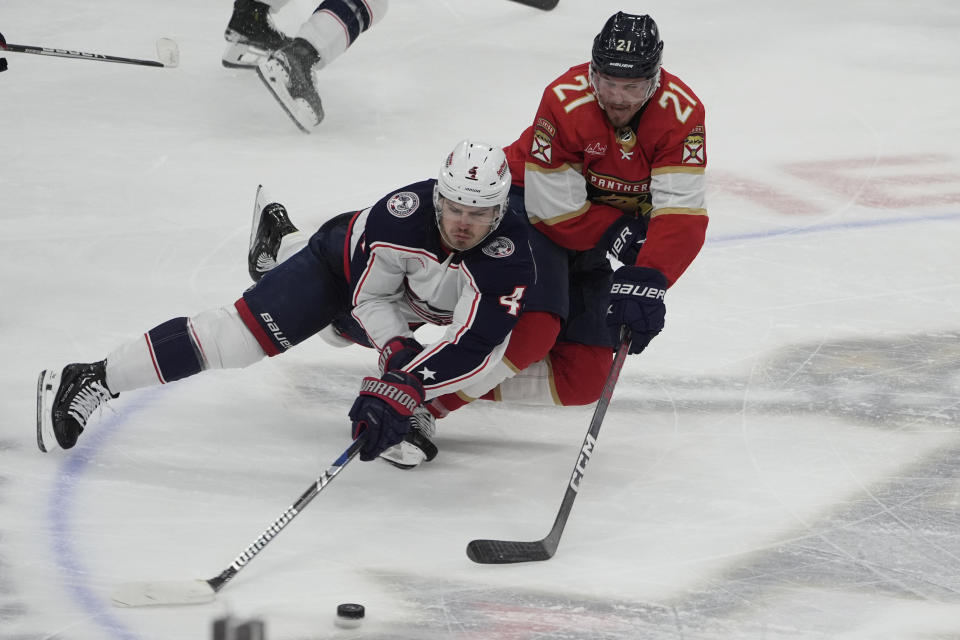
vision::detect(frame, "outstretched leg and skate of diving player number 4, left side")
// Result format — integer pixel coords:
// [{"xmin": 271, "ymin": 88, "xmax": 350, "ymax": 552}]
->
[{"xmin": 37, "ymin": 214, "xmax": 350, "ymax": 451}]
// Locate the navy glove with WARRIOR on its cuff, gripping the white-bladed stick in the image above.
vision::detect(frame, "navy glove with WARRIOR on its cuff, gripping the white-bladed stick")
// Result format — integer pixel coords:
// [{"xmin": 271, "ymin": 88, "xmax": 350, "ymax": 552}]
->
[{"xmin": 350, "ymin": 371, "xmax": 424, "ymax": 461}]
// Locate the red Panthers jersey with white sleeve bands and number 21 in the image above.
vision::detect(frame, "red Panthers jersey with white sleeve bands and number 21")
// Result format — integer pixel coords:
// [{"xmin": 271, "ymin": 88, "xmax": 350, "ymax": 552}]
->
[{"xmin": 505, "ymin": 63, "xmax": 707, "ymax": 284}]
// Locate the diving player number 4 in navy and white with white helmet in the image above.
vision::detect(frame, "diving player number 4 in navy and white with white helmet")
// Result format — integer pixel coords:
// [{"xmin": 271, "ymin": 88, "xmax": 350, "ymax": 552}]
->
[{"xmin": 37, "ymin": 141, "xmax": 534, "ymax": 466}]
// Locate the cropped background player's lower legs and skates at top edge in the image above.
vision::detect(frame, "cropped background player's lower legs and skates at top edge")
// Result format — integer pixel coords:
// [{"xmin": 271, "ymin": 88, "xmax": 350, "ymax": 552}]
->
[{"xmin": 223, "ymin": 0, "xmax": 388, "ymax": 133}]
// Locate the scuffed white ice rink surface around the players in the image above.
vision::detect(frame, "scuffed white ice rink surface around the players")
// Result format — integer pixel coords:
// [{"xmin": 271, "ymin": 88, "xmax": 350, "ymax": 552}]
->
[{"xmin": 0, "ymin": 0, "xmax": 960, "ymax": 640}]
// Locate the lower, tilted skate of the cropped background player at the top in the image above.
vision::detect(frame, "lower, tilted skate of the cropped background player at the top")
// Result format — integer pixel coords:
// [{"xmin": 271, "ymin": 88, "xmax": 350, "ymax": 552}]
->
[{"xmin": 257, "ymin": 38, "xmax": 323, "ymax": 133}]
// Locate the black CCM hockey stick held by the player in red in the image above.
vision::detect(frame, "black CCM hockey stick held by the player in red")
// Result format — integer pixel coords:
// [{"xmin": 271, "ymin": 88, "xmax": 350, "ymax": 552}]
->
[{"xmin": 467, "ymin": 327, "xmax": 630, "ymax": 564}]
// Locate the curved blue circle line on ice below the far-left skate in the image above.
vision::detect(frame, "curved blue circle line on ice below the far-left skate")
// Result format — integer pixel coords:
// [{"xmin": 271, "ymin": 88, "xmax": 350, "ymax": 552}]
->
[{"xmin": 45, "ymin": 398, "xmax": 146, "ymax": 640}]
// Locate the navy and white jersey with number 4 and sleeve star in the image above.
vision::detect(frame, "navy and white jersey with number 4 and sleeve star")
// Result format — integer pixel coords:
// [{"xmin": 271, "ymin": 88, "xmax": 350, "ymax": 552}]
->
[{"xmin": 347, "ymin": 180, "xmax": 535, "ymax": 398}]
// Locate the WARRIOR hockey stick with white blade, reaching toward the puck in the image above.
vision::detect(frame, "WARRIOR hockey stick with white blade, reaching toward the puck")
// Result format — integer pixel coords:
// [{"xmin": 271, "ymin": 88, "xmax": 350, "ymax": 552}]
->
[{"xmin": 111, "ymin": 437, "xmax": 363, "ymax": 607}]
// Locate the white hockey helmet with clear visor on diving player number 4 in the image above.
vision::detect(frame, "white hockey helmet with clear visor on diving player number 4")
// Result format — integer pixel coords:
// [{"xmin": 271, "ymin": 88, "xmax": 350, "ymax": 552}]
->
[{"xmin": 433, "ymin": 140, "xmax": 510, "ymax": 233}]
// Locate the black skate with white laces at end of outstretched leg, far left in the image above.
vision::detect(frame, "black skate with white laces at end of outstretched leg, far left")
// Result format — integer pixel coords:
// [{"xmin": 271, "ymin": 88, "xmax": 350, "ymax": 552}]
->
[{"xmin": 37, "ymin": 360, "xmax": 118, "ymax": 452}]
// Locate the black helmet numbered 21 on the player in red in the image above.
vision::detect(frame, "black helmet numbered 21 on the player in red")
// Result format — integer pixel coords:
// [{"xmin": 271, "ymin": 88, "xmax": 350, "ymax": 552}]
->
[{"xmin": 591, "ymin": 11, "xmax": 663, "ymax": 78}]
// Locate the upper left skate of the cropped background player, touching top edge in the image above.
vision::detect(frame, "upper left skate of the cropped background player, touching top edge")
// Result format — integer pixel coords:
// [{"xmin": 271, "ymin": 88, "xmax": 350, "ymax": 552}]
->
[{"xmin": 223, "ymin": 0, "xmax": 290, "ymax": 69}]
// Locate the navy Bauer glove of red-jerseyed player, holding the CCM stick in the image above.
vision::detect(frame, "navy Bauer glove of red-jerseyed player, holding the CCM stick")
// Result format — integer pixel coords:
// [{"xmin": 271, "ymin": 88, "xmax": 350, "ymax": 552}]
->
[{"xmin": 607, "ymin": 267, "xmax": 667, "ymax": 353}]
